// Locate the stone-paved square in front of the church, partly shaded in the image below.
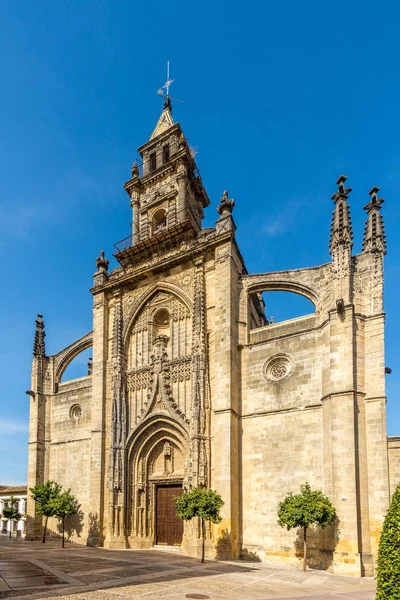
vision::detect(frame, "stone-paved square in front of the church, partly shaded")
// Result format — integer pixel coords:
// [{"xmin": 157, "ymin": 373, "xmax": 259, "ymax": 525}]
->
[{"xmin": 0, "ymin": 535, "xmax": 375, "ymax": 600}]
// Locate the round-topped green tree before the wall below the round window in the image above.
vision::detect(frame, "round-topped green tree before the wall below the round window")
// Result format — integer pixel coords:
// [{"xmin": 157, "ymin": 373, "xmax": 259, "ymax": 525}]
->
[{"xmin": 278, "ymin": 482, "xmax": 337, "ymax": 571}]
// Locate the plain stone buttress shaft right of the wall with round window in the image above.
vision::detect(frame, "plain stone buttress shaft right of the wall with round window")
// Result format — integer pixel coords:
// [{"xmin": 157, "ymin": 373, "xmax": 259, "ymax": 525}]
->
[{"xmin": 323, "ymin": 307, "xmax": 361, "ymax": 576}]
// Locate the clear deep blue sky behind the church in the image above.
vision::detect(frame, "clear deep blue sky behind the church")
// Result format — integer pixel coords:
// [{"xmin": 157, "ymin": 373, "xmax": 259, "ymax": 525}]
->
[{"xmin": 0, "ymin": 0, "xmax": 400, "ymax": 484}]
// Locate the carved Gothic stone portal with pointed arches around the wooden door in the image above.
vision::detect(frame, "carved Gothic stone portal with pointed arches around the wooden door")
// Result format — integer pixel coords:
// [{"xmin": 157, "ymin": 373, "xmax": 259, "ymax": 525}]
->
[{"xmin": 124, "ymin": 258, "xmax": 211, "ymax": 539}]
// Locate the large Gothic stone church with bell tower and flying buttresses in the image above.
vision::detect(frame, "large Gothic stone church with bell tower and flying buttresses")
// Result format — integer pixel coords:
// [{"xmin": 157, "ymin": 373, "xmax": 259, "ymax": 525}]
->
[{"xmin": 27, "ymin": 96, "xmax": 400, "ymax": 575}]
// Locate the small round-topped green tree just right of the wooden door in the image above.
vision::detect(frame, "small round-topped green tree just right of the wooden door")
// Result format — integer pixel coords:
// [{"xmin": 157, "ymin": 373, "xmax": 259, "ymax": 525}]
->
[{"xmin": 175, "ymin": 487, "xmax": 224, "ymax": 562}]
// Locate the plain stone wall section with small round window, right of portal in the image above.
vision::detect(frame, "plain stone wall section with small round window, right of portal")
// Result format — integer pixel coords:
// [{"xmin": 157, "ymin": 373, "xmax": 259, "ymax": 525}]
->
[{"xmin": 241, "ymin": 315, "xmax": 333, "ymax": 564}]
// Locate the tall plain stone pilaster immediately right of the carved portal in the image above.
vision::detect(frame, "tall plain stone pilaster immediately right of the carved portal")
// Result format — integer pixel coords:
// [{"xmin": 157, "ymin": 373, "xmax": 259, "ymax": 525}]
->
[{"xmin": 211, "ymin": 241, "xmax": 240, "ymax": 558}]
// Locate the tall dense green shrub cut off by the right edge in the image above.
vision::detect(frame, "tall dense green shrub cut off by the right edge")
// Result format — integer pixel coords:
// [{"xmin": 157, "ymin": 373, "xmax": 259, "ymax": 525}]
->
[{"xmin": 376, "ymin": 485, "xmax": 400, "ymax": 600}]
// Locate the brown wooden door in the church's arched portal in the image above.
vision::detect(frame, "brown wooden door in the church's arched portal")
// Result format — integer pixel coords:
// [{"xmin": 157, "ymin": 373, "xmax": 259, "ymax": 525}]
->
[{"xmin": 156, "ymin": 485, "xmax": 183, "ymax": 546}]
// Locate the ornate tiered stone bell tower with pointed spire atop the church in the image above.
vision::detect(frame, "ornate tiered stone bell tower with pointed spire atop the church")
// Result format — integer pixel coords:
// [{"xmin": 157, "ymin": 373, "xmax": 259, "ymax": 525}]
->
[{"xmin": 115, "ymin": 95, "xmax": 210, "ymax": 267}]
